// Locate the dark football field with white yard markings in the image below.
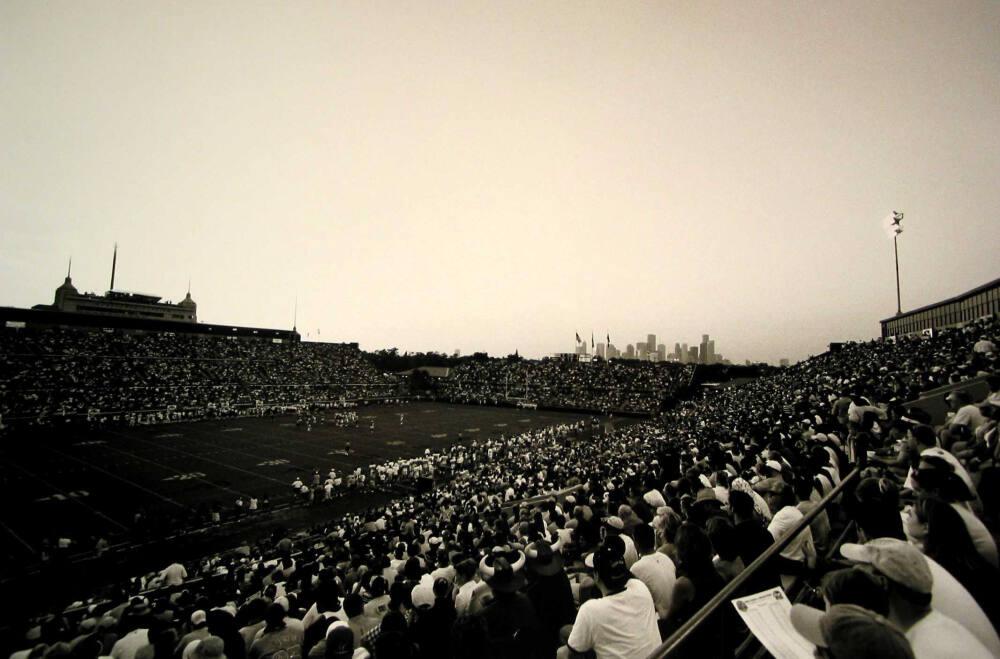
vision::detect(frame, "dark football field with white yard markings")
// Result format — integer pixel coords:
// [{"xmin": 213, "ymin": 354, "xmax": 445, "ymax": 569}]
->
[{"xmin": 0, "ymin": 403, "xmax": 589, "ymax": 558}]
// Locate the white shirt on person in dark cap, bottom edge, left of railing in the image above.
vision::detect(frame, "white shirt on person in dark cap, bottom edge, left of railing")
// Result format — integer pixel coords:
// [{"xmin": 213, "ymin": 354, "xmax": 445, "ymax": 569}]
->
[{"xmin": 567, "ymin": 579, "xmax": 660, "ymax": 659}]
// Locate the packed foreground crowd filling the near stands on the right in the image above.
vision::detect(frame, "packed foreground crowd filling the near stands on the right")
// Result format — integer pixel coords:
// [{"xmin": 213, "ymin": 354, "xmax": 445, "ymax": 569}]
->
[{"xmin": 3, "ymin": 321, "xmax": 1000, "ymax": 659}]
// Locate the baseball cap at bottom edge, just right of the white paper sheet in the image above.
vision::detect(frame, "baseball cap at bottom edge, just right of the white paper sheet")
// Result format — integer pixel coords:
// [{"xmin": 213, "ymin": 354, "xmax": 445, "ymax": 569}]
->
[{"xmin": 789, "ymin": 604, "xmax": 913, "ymax": 659}]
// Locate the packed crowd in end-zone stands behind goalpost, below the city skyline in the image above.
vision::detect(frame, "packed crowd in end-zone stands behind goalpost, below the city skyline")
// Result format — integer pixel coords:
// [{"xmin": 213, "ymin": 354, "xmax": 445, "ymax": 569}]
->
[{"xmin": 442, "ymin": 359, "xmax": 693, "ymax": 413}]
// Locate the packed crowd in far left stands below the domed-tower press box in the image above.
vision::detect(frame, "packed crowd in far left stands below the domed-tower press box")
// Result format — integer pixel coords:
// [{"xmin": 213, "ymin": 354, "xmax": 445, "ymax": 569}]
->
[{"xmin": 0, "ymin": 328, "xmax": 397, "ymax": 425}]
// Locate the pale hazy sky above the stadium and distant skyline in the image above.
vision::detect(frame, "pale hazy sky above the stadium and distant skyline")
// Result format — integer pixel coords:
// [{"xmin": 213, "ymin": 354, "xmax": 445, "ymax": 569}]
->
[{"xmin": 0, "ymin": 0, "xmax": 1000, "ymax": 361}]
